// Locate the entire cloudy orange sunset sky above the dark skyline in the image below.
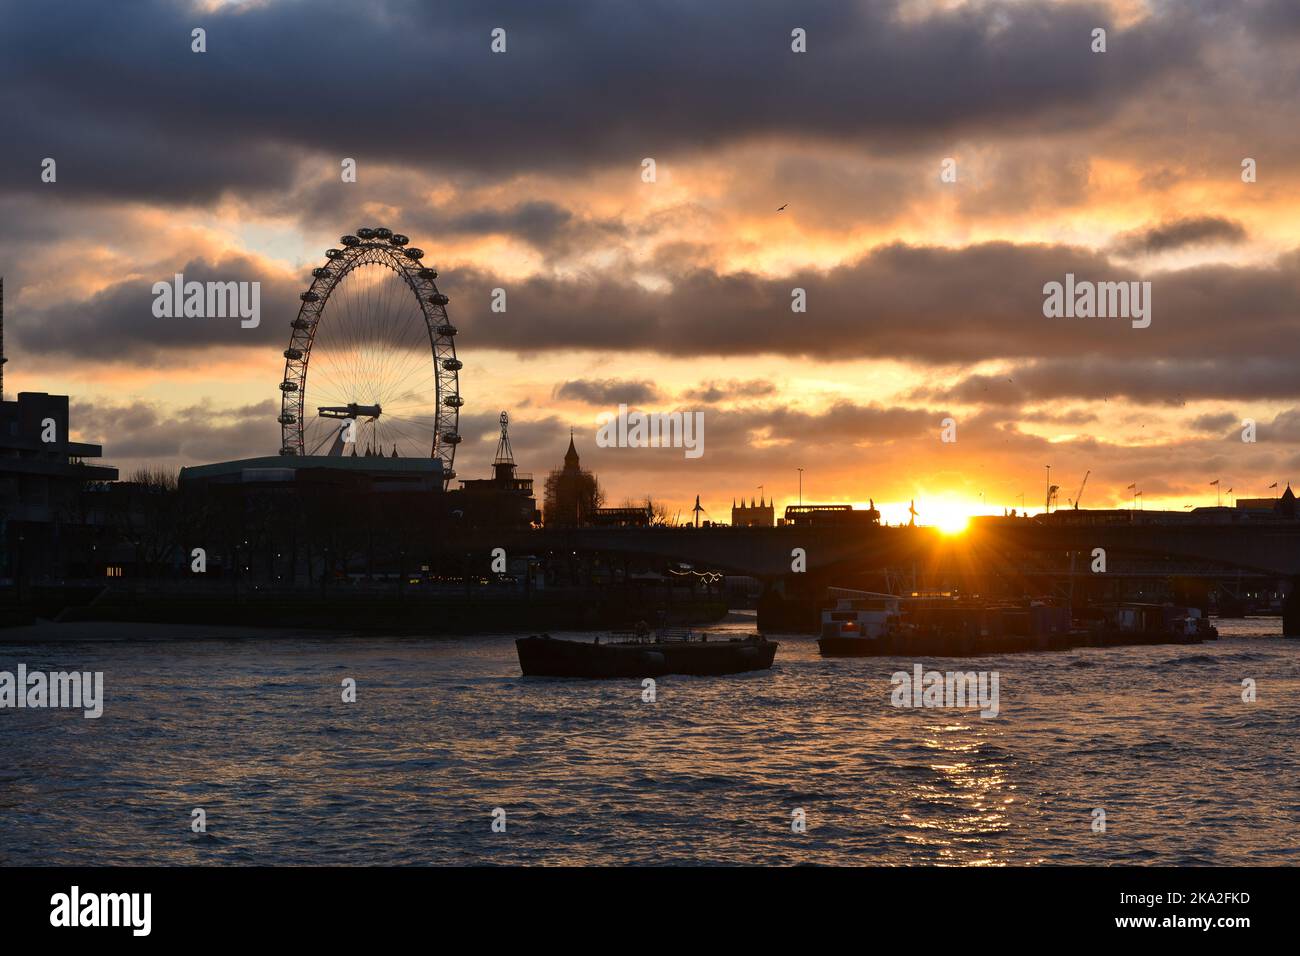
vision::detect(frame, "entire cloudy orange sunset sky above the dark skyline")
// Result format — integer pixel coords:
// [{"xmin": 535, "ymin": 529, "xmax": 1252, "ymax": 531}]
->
[{"xmin": 0, "ymin": 0, "xmax": 1300, "ymax": 522}]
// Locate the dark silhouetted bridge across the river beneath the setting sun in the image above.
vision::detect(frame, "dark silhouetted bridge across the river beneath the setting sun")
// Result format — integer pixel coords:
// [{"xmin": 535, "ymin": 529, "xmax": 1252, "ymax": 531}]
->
[{"xmin": 473, "ymin": 509, "xmax": 1300, "ymax": 632}]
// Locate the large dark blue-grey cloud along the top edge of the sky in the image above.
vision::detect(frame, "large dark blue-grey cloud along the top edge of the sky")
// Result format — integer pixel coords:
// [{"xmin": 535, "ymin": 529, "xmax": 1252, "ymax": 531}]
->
[{"xmin": 0, "ymin": 0, "xmax": 1201, "ymax": 202}]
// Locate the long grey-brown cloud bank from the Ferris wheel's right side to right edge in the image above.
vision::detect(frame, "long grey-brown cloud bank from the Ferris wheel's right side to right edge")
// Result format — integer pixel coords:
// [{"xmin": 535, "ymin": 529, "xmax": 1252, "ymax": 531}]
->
[{"xmin": 447, "ymin": 242, "xmax": 1300, "ymax": 371}]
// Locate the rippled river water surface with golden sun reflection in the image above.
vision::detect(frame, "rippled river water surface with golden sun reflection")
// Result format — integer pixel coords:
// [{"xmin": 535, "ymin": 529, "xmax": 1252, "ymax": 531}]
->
[{"xmin": 0, "ymin": 619, "xmax": 1300, "ymax": 865}]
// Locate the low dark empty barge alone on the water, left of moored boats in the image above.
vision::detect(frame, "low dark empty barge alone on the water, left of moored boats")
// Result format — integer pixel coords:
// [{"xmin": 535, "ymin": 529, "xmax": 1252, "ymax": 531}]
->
[{"xmin": 515, "ymin": 623, "xmax": 779, "ymax": 678}]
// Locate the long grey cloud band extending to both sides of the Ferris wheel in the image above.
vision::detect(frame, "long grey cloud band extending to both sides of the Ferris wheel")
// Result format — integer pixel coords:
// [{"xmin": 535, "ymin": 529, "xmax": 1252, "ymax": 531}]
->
[{"xmin": 17, "ymin": 242, "xmax": 1300, "ymax": 390}]
